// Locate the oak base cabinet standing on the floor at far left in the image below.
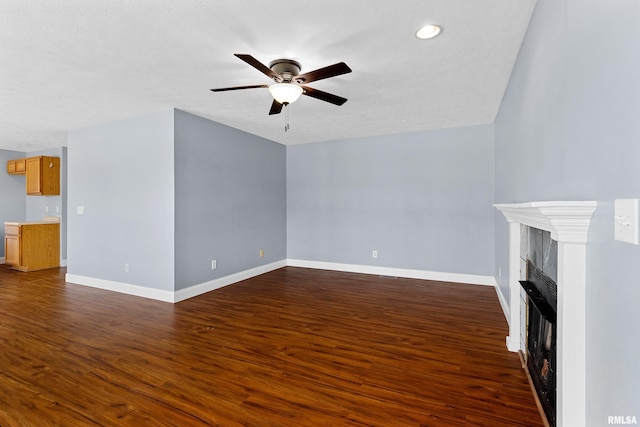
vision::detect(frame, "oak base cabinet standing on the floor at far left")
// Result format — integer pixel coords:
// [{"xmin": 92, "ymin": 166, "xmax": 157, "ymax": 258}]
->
[{"xmin": 4, "ymin": 222, "xmax": 60, "ymax": 271}]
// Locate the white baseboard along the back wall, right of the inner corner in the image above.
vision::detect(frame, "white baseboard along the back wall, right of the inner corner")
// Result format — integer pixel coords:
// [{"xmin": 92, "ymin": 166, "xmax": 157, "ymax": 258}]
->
[{"xmin": 287, "ymin": 259, "xmax": 497, "ymax": 287}]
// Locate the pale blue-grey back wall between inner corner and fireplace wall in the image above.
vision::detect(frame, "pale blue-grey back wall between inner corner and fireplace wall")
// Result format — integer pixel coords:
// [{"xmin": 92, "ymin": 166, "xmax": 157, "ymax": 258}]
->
[{"xmin": 287, "ymin": 125, "xmax": 494, "ymax": 276}]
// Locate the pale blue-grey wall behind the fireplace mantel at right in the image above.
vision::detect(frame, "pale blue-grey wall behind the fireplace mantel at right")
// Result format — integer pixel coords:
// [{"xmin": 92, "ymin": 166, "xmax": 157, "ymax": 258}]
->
[{"xmin": 495, "ymin": 0, "xmax": 640, "ymax": 426}]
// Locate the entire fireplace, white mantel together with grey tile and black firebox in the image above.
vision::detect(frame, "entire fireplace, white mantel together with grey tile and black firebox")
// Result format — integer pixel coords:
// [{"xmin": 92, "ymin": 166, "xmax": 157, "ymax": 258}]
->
[{"xmin": 495, "ymin": 201, "xmax": 597, "ymax": 427}]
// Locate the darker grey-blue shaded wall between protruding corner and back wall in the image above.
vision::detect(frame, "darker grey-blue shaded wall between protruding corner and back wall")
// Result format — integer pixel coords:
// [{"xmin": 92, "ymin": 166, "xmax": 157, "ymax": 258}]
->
[{"xmin": 175, "ymin": 110, "xmax": 287, "ymax": 289}]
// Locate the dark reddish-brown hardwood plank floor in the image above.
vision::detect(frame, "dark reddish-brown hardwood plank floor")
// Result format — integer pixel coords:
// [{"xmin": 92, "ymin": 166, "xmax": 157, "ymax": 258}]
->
[{"xmin": 0, "ymin": 265, "xmax": 543, "ymax": 427}]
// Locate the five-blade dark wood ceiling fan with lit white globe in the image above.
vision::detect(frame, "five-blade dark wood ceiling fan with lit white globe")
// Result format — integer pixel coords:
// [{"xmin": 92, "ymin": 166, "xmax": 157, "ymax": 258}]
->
[{"xmin": 211, "ymin": 53, "xmax": 351, "ymax": 115}]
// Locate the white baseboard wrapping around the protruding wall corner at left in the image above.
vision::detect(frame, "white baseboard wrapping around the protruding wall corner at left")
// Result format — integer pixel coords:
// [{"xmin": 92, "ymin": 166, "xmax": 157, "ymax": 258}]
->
[{"xmin": 65, "ymin": 260, "xmax": 287, "ymax": 303}]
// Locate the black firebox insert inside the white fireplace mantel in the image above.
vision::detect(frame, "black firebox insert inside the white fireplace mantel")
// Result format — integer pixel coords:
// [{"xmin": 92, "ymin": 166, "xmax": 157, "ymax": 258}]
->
[{"xmin": 520, "ymin": 261, "xmax": 557, "ymax": 426}]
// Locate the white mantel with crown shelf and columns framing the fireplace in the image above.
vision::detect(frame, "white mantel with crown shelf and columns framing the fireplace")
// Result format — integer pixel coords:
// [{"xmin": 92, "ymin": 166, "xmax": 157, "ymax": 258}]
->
[{"xmin": 494, "ymin": 201, "xmax": 597, "ymax": 427}]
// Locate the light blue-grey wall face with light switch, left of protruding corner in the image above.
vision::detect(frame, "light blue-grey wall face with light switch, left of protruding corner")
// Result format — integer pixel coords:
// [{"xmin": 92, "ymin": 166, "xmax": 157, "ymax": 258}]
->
[{"xmin": 67, "ymin": 110, "xmax": 175, "ymax": 291}]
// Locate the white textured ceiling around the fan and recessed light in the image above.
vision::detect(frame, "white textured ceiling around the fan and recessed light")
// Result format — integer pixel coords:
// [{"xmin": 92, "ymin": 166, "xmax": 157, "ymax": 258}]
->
[{"xmin": 0, "ymin": 0, "xmax": 535, "ymax": 151}]
